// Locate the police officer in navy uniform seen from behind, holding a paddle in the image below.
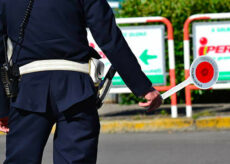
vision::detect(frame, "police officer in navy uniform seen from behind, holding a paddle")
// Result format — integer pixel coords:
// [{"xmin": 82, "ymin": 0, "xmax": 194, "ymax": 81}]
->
[{"xmin": 0, "ymin": 0, "xmax": 162, "ymax": 164}]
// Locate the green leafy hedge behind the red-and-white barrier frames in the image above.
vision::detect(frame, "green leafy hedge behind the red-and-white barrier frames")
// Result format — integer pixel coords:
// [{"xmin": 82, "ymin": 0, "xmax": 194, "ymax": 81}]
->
[{"xmin": 117, "ymin": 0, "xmax": 230, "ymax": 103}]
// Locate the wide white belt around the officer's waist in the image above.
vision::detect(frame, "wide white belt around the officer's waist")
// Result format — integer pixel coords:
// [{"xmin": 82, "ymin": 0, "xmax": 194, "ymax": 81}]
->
[{"xmin": 19, "ymin": 59, "xmax": 90, "ymax": 75}]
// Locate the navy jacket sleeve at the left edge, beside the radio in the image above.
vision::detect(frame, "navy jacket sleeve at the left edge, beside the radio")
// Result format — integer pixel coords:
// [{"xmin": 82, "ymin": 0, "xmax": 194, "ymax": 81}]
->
[{"xmin": 0, "ymin": 0, "xmax": 9, "ymax": 118}]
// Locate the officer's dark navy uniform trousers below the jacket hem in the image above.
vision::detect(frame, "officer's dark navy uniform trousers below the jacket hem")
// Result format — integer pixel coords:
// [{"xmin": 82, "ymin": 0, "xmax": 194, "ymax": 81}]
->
[{"xmin": 4, "ymin": 96, "xmax": 100, "ymax": 164}]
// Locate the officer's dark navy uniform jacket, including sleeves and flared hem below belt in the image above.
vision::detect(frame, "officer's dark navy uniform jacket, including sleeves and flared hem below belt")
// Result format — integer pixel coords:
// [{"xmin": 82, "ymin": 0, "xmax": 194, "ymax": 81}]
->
[{"xmin": 0, "ymin": 0, "xmax": 152, "ymax": 117}]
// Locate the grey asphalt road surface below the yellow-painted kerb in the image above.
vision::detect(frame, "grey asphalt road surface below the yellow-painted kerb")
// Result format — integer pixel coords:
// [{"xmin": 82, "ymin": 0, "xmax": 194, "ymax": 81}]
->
[{"xmin": 0, "ymin": 131, "xmax": 230, "ymax": 164}]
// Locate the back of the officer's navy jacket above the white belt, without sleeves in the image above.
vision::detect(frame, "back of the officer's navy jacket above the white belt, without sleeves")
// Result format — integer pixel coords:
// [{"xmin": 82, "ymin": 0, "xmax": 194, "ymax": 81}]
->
[{"xmin": 5, "ymin": 0, "xmax": 92, "ymax": 65}]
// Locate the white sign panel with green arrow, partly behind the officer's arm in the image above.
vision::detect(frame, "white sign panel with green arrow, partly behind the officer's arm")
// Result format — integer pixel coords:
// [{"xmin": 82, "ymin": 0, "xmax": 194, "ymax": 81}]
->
[{"xmin": 88, "ymin": 25, "xmax": 166, "ymax": 91}]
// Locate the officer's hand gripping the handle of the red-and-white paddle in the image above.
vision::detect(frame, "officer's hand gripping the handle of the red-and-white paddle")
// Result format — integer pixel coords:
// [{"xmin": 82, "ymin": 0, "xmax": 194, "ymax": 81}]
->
[{"xmin": 139, "ymin": 90, "xmax": 163, "ymax": 112}]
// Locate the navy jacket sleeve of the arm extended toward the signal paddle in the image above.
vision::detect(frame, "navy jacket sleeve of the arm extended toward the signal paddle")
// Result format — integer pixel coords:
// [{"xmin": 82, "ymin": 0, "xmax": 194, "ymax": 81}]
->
[{"xmin": 84, "ymin": 0, "xmax": 153, "ymax": 96}]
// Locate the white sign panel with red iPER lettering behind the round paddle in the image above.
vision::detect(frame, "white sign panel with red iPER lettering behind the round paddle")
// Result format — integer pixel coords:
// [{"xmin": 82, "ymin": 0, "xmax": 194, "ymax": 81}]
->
[{"xmin": 193, "ymin": 21, "xmax": 230, "ymax": 82}]
